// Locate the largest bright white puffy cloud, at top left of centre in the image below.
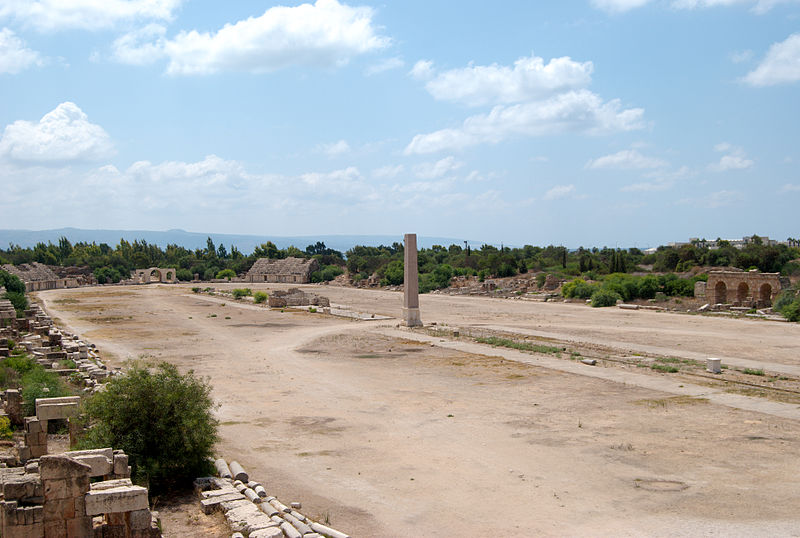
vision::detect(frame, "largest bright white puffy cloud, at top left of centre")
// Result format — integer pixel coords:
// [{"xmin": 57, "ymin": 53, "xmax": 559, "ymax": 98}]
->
[{"xmin": 123, "ymin": 0, "xmax": 390, "ymax": 75}]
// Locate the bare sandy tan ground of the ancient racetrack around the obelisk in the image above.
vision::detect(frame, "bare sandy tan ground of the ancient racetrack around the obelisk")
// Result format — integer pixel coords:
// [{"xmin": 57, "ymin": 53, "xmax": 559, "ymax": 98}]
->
[{"xmin": 34, "ymin": 286, "xmax": 800, "ymax": 537}]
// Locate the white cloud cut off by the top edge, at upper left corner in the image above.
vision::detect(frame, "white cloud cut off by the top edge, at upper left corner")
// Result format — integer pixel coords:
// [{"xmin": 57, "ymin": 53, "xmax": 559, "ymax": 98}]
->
[{"xmin": 0, "ymin": 0, "xmax": 182, "ymax": 31}]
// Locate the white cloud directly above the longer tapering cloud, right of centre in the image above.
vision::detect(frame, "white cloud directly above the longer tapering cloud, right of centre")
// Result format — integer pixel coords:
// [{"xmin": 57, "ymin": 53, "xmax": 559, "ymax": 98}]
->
[{"xmin": 422, "ymin": 55, "xmax": 594, "ymax": 106}]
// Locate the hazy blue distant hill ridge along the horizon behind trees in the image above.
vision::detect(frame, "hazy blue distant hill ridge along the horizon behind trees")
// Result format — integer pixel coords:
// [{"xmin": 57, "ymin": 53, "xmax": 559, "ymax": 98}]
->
[{"xmin": 0, "ymin": 228, "xmax": 483, "ymax": 254}]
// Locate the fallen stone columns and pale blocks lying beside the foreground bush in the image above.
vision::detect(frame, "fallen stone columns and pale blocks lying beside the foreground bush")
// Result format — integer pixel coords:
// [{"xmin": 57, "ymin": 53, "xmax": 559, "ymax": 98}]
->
[{"xmin": 194, "ymin": 458, "xmax": 350, "ymax": 538}]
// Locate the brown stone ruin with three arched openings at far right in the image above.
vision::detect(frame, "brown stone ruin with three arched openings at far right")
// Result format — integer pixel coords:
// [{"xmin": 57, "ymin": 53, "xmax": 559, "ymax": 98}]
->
[{"xmin": 696, "ymin": 271, "xmax": 789, "ymax": 308}]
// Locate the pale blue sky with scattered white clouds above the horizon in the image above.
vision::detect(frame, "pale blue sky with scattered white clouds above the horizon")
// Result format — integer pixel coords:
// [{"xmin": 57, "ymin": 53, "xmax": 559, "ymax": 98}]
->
[{"xmin": 0, "ymin": 0, "xmax": 800, "ymax": 248}]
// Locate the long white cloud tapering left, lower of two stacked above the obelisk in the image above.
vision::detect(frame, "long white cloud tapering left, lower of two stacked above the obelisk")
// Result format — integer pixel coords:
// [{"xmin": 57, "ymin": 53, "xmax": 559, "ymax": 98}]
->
[{"xmin": 405, "ymin": 90, "xmax": 644, "ymax": 155}]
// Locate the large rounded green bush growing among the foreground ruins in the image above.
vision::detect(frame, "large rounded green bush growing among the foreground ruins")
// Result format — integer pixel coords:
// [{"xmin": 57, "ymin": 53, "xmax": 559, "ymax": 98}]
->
[{"xmin": 81, "ymin": 363, "xmax": 218, "ymax": 493}]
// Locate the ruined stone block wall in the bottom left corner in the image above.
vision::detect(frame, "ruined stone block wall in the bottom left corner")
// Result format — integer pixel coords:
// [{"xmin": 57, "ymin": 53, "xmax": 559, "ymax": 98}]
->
[{"xmin": 0, "ymin": 448, "xmax": 161, "ymax": 538}]
